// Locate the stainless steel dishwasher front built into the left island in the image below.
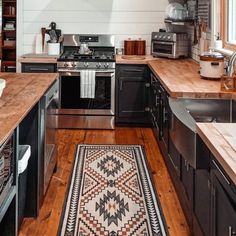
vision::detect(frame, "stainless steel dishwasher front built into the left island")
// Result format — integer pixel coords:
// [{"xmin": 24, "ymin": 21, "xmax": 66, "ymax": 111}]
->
[{"xmin": 41, "ymin": 80, "xmax": 59, "ymax": 194}]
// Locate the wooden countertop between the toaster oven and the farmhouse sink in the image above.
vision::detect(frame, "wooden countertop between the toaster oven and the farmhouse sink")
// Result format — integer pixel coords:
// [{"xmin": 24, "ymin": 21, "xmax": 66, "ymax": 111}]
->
[{"xmin": 148, "ymin": 58, "xmax": 236, "ymax": 98}]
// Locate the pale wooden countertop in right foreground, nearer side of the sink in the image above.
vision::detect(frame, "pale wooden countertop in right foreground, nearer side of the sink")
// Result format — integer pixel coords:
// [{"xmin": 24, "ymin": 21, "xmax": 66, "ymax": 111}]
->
[{"xmin": 197, "ymin": 123, "xmax": 236, "ymax": 184}]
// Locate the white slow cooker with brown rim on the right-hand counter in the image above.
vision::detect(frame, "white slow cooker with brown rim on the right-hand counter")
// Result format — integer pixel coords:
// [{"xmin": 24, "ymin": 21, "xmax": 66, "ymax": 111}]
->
[{"xmin": 200, "ymin": 52, "xmax": 224, "ymax": 79}]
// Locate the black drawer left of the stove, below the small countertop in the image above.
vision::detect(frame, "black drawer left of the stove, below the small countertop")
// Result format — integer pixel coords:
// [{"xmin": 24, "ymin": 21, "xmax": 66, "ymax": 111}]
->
[{"xmin": 22, "ymin": 63, "xmax": 57, "ymax": 73}]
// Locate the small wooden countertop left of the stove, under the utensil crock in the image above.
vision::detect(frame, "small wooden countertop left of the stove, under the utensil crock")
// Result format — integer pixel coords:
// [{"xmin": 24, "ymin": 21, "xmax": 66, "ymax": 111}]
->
[{"xmin": 18, "ymin": 53, "xmax": 59, "ymax": 64}]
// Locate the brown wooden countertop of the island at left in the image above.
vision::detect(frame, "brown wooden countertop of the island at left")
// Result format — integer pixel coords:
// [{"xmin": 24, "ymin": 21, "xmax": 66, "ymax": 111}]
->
[{"xmin": 0, "ymin": 73, "xmax": 58, "ymax": 145}]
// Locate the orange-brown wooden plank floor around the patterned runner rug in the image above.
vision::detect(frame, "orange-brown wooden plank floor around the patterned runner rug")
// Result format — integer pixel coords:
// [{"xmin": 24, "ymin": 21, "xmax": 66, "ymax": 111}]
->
[{"xmin": 20, "ymin": 128, "xmax": 189, "ymax": 236}]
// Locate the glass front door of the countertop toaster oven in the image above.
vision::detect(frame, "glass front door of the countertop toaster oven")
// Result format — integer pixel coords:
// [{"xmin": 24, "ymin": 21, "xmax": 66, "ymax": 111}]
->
[{"xmin": 152, "ymin": 40, "xmax": 176, "ymax": 58}]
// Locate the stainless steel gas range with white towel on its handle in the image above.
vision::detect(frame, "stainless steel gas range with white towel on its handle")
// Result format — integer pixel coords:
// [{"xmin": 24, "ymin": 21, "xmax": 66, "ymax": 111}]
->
[{"xmin": 57, "ymin": 34, "xmax": 115, "ymax": 129}]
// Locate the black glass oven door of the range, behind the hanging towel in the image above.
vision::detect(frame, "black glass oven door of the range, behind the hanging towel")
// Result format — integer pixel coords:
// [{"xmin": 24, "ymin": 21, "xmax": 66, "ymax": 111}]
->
[{"xmin": 60, "ymin": 71, "xmax": 115, "ymax": 115}]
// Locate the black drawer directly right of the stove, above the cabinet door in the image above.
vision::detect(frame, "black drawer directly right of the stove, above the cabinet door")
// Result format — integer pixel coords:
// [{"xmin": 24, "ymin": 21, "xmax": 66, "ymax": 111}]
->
[{"xmin": 118, "ymin": 65, "xmax": 147, "ymax": 77}]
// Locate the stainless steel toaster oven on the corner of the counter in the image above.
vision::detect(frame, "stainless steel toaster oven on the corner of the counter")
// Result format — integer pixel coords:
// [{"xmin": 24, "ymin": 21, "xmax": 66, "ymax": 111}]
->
[{"xmin": 151, "ymin": 32, "xmax": 189, "ymax": 59}]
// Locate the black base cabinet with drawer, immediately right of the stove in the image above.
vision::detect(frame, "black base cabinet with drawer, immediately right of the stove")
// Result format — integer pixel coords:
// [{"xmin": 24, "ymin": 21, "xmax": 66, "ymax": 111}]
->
[{"xmin": 116, "ymin": 65, "xmax": 150, "ymax": 124}]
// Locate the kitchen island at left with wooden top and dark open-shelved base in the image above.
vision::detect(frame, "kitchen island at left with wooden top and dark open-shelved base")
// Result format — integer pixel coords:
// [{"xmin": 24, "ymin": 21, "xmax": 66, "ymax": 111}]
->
[{"xmin": 0, "ymin": 73, "xmax": 58, "ymax": 235}]
